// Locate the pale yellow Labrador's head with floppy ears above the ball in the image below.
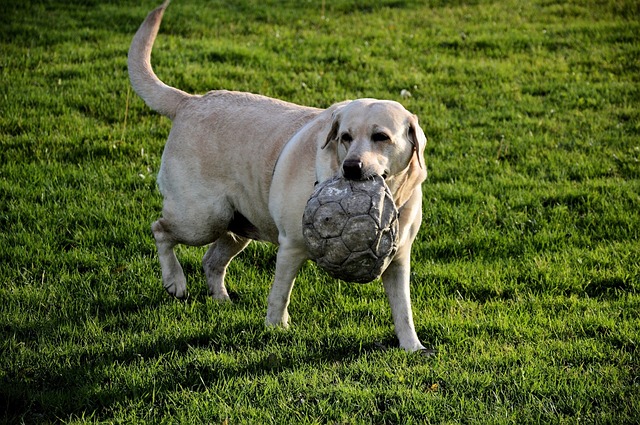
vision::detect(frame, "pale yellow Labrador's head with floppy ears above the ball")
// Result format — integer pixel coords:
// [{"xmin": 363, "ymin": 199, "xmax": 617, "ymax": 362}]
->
[{"xmin": 321, "ymin": 99, "xmax": 427, "ymax": 205}]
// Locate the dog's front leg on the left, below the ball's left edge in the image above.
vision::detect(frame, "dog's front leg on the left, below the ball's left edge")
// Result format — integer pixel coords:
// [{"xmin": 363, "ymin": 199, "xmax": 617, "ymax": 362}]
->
[{"xmin": 266, "ymin": 242, "xmax": 308, "ymax": 328}]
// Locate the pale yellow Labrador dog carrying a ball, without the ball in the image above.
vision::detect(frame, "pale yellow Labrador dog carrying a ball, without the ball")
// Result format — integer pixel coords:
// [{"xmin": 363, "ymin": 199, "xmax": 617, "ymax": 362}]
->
[{"xmin": 128, "ymin": 1, "xmax": 427, "ymax": 352}]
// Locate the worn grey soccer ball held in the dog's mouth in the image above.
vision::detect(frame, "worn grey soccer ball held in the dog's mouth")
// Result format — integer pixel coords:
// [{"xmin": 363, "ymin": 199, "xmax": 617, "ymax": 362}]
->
[{"xmin": 302, "ymin": 176, "xmax": 398, "ymax": 283}]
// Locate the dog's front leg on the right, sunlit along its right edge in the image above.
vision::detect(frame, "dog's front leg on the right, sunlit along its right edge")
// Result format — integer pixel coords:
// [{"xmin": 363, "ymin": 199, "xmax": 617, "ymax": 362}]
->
[{"xmin": 382, "ymin": 255, "xmax": 425, "ymax": 351}]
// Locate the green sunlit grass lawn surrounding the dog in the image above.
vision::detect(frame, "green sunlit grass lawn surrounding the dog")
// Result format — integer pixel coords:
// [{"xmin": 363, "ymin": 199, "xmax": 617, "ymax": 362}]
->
[{"xmin": 0, "ymin": 0, "xmax": 640, "ymax": 424}]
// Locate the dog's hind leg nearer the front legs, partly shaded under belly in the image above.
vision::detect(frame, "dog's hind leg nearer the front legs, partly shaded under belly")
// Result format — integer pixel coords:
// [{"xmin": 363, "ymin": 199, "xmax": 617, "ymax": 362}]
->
[{"xmin": 202, "ymin": 232, "xmax": 251, "ymax": 301}]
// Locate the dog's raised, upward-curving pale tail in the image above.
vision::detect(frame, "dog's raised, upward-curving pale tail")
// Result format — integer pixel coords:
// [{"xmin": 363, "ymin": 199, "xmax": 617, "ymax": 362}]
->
[{"xmin": 128, "ymin": 0, "xmax": 191, "ymax": 119}]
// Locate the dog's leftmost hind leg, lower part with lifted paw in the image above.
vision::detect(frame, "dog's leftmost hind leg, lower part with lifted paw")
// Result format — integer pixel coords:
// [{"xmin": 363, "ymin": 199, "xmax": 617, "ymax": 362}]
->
[{"xmin": 151, "ymin": 218, "xmax": 187, "ymax": 298}]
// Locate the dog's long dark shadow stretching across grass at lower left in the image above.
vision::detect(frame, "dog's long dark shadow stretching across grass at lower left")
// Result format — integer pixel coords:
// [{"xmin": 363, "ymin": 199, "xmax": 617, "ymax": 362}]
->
[{"xmin": 0, "ymin": 295, "xmax": 410, "ymax": 423}]
